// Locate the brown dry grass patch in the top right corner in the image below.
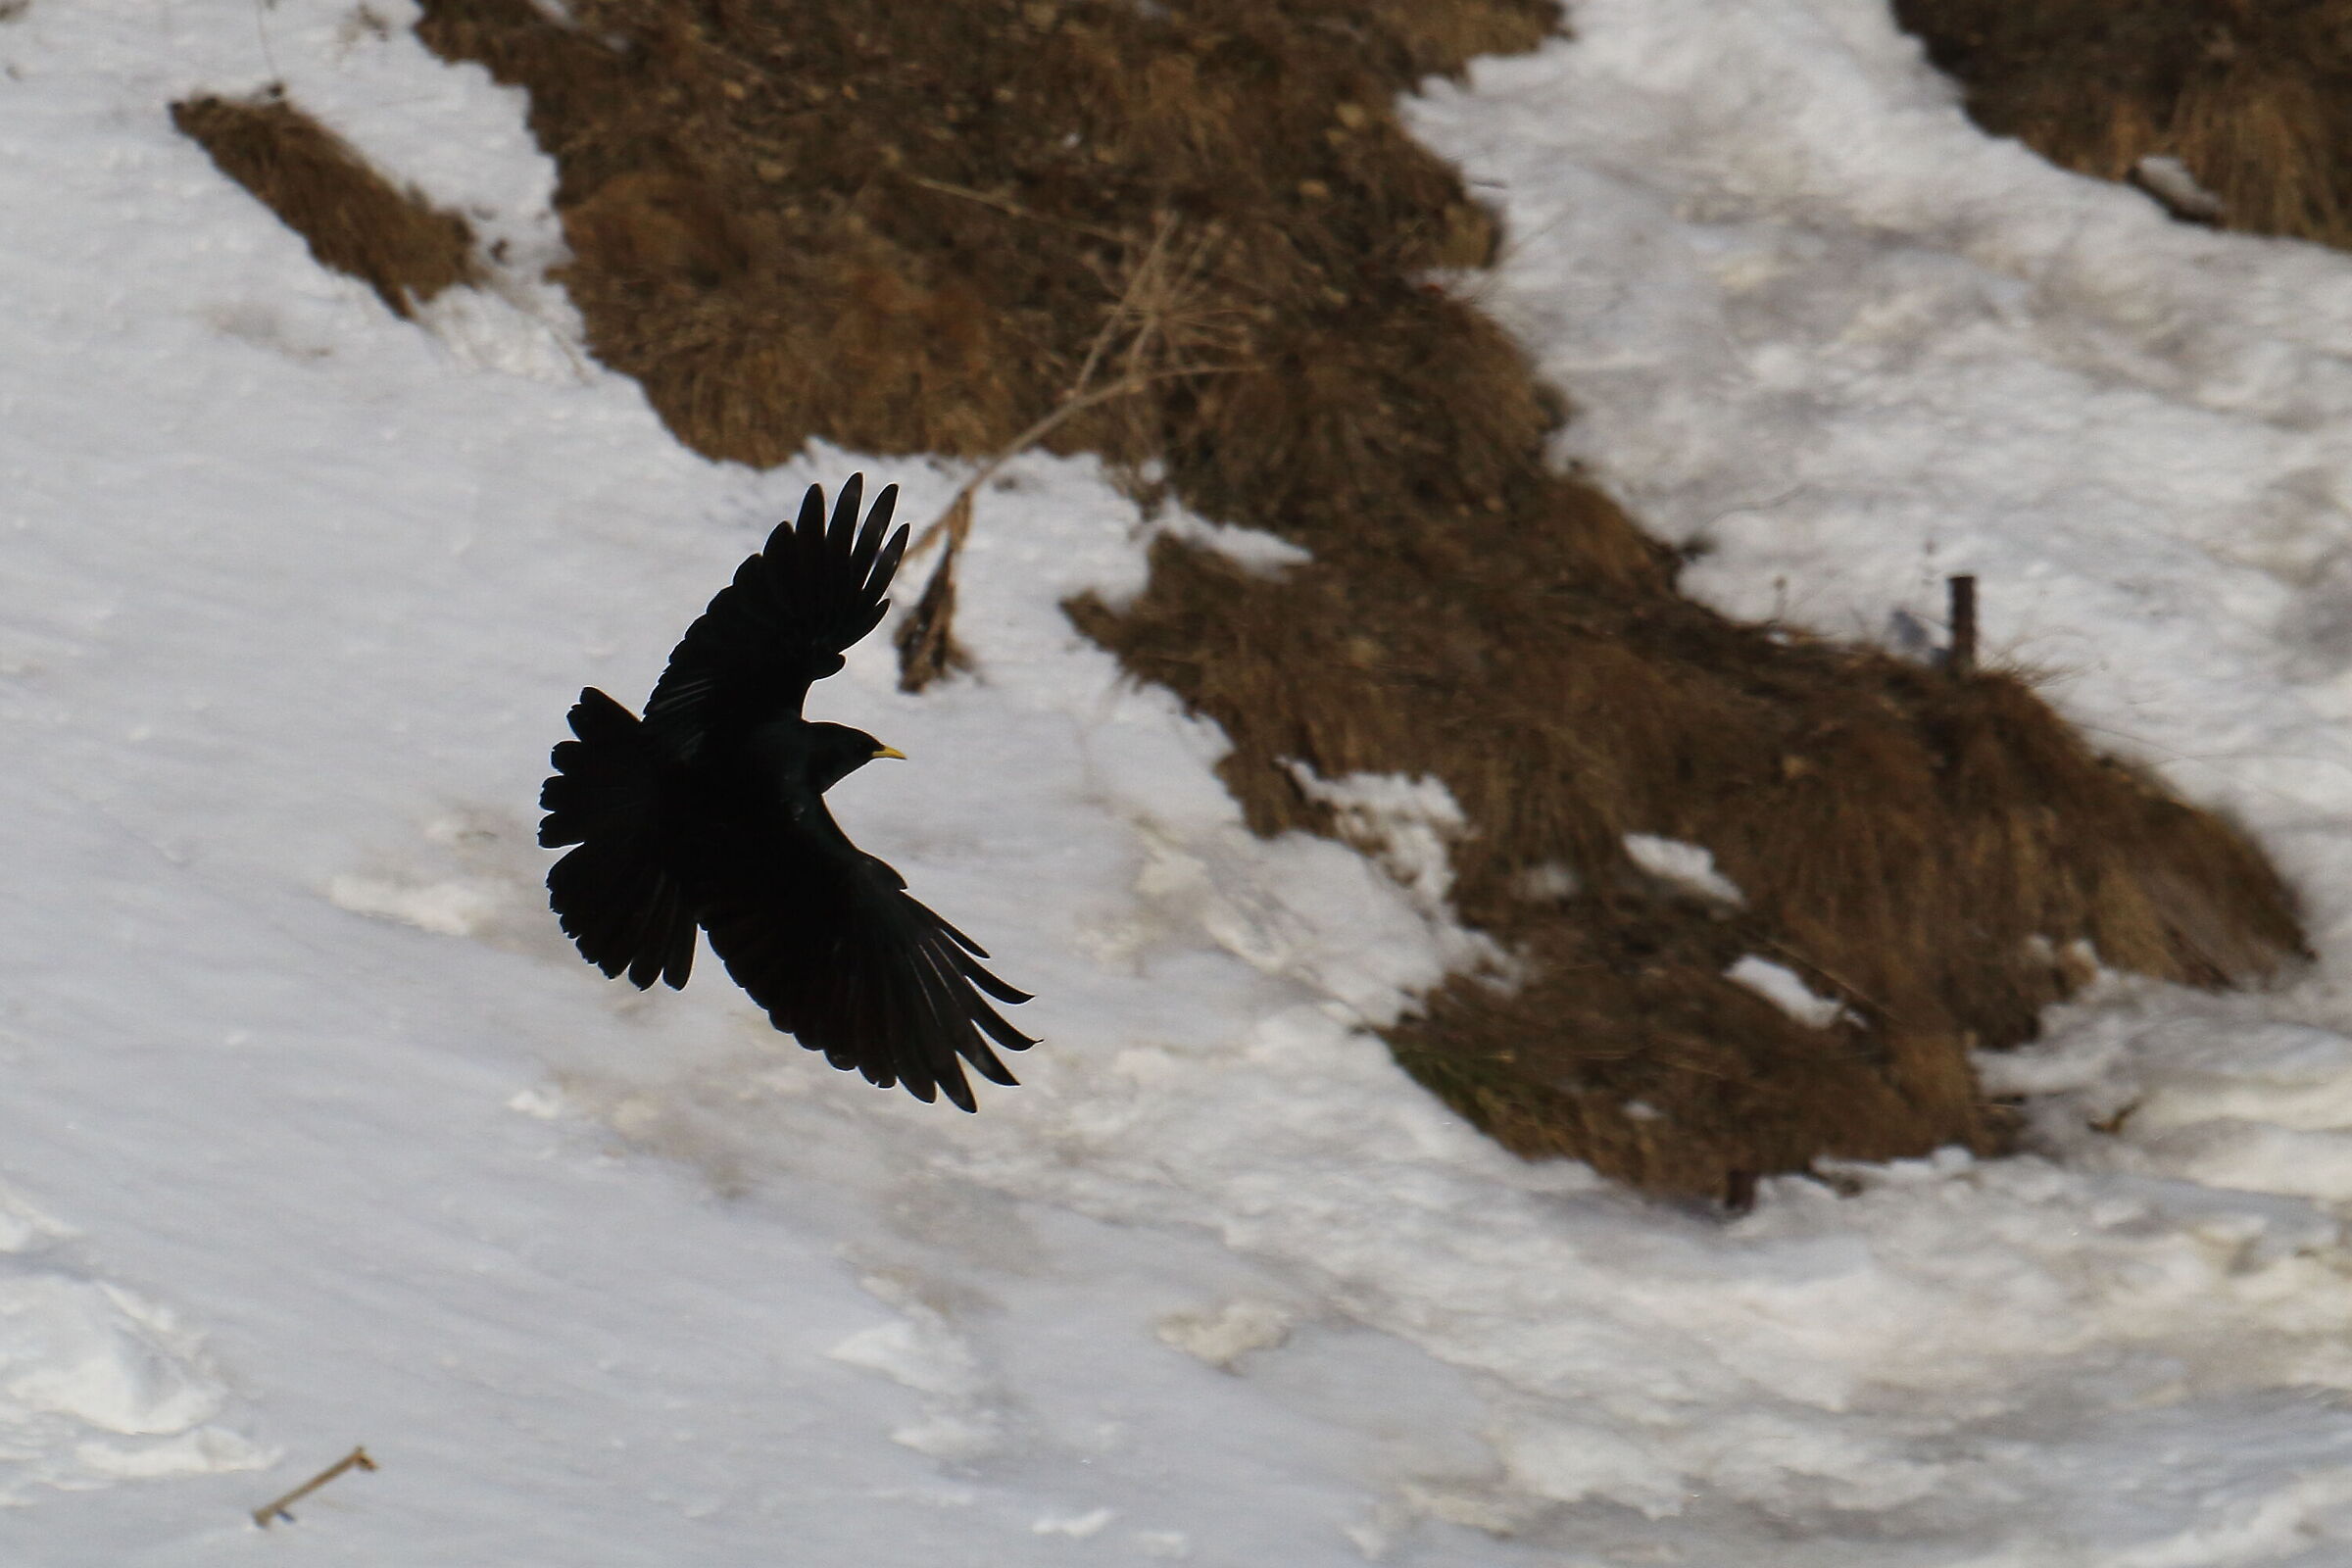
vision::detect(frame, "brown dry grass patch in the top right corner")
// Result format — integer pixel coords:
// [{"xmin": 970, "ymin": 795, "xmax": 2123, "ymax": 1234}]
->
[{"xmin": 1895, "ymin": 0, "xmax": 2352, "ymax": 247}]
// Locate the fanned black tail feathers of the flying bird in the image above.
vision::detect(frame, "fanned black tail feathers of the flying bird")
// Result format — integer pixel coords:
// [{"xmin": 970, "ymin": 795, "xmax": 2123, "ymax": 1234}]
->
[{"xmin": 539, "ymin": 686, "xmax": 694, "ymax": 990}]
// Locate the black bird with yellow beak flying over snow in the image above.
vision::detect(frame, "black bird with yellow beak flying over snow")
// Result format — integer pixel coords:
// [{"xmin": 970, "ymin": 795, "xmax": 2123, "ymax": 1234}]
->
[{"xmin": 539, "ymin": 475, "xmax": 1035, "ymax": 1109}]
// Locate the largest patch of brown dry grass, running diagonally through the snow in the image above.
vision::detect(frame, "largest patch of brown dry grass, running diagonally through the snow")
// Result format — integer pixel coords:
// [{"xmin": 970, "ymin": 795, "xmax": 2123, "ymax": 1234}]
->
[{"xmin": 421, "ymin": 0, "xmax": 2300, "ymax": 1195}]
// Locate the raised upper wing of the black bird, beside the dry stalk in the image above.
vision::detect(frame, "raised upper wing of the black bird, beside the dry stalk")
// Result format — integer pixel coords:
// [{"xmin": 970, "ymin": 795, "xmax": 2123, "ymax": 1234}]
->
[{"xmin": 645, "ymin": 475, "xmax": 906, "ymax": 760}]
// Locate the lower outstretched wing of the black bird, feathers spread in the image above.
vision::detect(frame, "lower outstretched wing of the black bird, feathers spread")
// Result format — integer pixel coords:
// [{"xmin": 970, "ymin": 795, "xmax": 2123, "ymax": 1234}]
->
[{"xmin": 701, "ymin": 832, "xmax": 1037, "ymax": 1109}]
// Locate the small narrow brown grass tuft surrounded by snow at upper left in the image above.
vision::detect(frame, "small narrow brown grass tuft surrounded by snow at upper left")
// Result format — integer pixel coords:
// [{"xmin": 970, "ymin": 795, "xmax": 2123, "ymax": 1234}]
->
[{"xmin": 172, "ymin": 96, "xmax": 482, "ymax": 318}]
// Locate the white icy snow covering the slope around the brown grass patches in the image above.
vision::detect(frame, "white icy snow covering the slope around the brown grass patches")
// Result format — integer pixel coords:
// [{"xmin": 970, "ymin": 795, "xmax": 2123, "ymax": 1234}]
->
[{"xmin": 14, "ymin": 0, "xmax": 2352, "ymax": 1568}]
